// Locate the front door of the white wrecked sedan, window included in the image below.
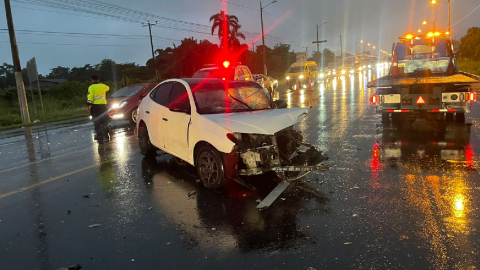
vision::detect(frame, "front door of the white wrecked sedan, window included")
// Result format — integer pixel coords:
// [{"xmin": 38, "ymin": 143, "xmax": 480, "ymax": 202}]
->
[{"xmin": 162, "ymin": 82, "xmax": 191, "ymax": 159}]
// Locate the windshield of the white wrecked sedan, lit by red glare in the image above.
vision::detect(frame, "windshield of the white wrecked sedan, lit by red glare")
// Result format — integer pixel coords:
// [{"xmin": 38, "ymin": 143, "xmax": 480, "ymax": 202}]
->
[{"xmin": 193, "ymin": 82, "xmax": 272, "ymax": 114}]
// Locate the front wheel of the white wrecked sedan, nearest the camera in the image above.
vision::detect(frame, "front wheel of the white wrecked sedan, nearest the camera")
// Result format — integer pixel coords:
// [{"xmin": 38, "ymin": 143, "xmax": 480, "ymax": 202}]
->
[{"xmin": 195, "ymin": 145, "xmax": 225, "ymax": 190}]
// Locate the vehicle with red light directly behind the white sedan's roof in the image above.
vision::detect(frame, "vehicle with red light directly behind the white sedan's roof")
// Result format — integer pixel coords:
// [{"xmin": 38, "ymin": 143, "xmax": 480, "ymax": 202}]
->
[{"xmin": 192, "ymin": 61, "xmax": 253, "ymax": 81}]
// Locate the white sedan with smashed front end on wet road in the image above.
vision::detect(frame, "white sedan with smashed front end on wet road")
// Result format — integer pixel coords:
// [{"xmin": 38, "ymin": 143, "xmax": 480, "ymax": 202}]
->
[{"xmin": 137, "ymin": 79, "xmax": 326, "ymax": 189}]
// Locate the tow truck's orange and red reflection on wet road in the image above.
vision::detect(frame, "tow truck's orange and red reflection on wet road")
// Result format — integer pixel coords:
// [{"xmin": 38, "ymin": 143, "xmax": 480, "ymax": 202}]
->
[{"xmin": 370, "ymin": 121, "xmax": 478, "ymax": 269}]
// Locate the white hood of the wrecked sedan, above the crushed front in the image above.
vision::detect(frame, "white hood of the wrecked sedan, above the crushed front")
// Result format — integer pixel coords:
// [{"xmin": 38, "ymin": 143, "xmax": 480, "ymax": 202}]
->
[{"xmin": 202, "ymin": 108, "xmax": 308, "ymax": 135}]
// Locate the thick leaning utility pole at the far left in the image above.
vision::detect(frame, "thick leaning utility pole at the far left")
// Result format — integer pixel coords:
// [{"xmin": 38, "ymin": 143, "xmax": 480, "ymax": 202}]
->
[{"xmin": 5, "ymin": 0, "xmax": 30, "ymax": 124}]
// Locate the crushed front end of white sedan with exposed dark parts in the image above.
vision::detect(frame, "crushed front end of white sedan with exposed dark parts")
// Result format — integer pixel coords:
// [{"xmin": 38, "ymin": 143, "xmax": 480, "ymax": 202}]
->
[{"xmin": 233, "ymin": 126, "xmax": 328, "ymax": 182}]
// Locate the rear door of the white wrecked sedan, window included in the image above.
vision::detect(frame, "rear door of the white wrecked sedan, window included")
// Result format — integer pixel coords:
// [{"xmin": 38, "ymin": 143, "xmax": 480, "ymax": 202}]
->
[{"xmin": 150, "ymin": 82, "xmax": 174, "ymax": 149}]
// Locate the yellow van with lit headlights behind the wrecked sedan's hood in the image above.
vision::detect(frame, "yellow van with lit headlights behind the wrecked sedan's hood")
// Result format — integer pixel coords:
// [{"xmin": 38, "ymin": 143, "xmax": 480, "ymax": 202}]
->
[{"xmin": 285, "ymin": 61, "xmax": 318, "ymax": 90}]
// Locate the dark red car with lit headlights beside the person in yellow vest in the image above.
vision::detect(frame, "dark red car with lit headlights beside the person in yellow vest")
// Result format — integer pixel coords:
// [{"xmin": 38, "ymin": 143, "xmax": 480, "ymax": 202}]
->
[{"xmin": 107, "ymin": 83, "xmax": 157, "ymax": 124}]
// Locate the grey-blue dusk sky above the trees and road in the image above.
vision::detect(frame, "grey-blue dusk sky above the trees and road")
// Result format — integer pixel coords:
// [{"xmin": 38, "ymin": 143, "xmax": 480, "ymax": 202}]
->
[{"xmin": 0, "ymin": 0, "xmax": 480, "ymax": 74}]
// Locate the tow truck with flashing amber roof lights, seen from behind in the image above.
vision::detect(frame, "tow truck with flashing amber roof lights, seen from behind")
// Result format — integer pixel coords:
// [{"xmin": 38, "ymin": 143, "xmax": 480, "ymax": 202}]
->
[{"xmin": 368, "ymin": 32, "xmax": 480, "ymax": 123}]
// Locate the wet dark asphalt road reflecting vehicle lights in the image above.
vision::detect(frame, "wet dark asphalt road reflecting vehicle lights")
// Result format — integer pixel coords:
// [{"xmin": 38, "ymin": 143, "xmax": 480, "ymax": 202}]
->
[{"xmin": 0, "ymin": 72, "xmax": 480, "ymax": 270}]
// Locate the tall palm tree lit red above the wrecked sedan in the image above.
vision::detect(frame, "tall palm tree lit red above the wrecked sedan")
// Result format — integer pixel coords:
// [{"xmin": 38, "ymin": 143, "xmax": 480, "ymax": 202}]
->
[{"xmin": 210, "ymin": 10, "xmax": 245, "ymax": 47}]
